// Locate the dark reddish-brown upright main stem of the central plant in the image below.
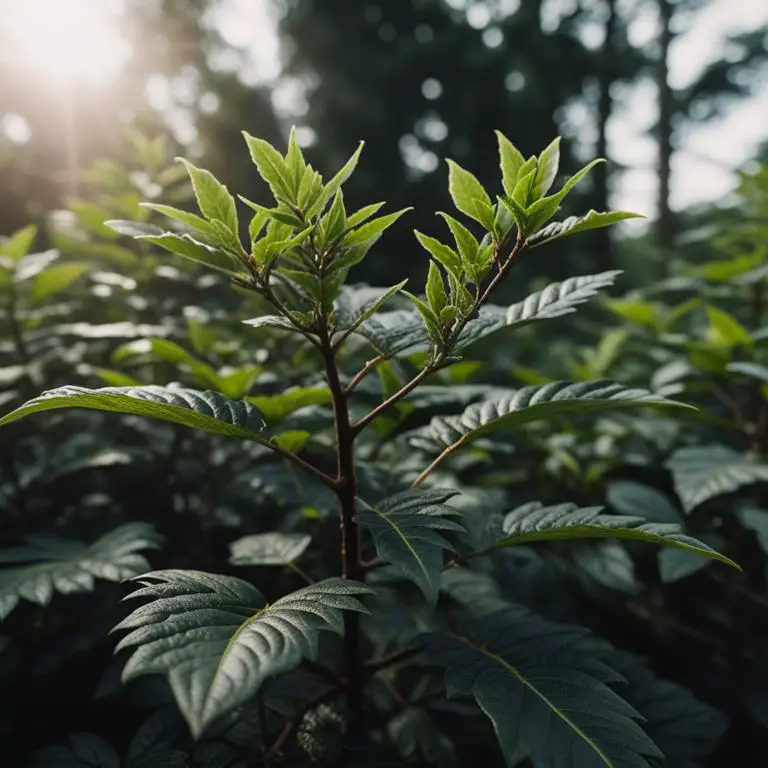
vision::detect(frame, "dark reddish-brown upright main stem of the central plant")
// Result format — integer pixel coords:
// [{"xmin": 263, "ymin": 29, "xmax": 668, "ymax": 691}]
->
[{"xmin": 320, "ymin": 322, "xmax": 364, "ymax": 734}]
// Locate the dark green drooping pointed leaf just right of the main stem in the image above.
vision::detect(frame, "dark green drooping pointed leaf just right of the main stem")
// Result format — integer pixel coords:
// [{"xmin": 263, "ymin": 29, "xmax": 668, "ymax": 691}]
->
[{"xmin": 355, "ymin": 489, "xmax": 464, "ymax": 605}]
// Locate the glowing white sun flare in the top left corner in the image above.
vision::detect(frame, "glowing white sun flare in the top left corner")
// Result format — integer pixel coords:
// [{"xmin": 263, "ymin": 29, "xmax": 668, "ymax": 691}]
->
[{"xmin": 0, "ymin": 0, "xmax": 130, "ymax": 82}]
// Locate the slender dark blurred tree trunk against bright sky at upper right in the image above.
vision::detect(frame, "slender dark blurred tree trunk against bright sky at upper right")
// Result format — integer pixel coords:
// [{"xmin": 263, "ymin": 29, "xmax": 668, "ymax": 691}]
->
[{"xmin": 656, "ymin": 0, "xmax": 675, "ymax": 249}]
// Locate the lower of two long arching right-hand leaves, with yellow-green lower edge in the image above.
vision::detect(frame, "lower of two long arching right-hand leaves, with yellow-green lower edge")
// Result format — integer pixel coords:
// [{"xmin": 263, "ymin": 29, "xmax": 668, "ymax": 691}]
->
[{"xmin": 486, "ymin": 501, "xmax": 741, "ymax": 570}]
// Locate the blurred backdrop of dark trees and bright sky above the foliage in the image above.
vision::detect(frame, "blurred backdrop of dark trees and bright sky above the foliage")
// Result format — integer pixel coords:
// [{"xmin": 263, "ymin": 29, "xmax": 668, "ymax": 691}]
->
[{"xmin": 0, "ymin": 0, "xmax": 768, "ymax": 283}]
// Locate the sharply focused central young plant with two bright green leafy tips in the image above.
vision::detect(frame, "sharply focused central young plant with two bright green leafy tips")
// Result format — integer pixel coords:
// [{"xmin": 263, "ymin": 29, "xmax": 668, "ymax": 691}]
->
[{"xmin": 0, "ymin": 133, "xmax": 737, "ymax": 768}]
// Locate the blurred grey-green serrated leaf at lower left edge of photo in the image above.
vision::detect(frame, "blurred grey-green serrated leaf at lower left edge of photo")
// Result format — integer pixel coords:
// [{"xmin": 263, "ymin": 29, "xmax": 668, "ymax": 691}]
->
[{"xmin": 0, "ymin": 523, "xmax": 162, "ymax": 620}]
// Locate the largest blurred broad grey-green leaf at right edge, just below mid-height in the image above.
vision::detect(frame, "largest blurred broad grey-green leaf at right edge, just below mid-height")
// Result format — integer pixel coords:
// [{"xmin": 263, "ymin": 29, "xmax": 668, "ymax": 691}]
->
[{"xmin": 666, "ymin": 445, "xmax": 768, "ymax": 512}]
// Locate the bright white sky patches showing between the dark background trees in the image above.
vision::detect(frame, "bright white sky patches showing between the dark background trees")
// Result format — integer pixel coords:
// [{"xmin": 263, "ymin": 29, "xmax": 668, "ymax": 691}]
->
[{"xmin": 0, "ymin": 0, "xmax": 768, "ymax": 219}]
